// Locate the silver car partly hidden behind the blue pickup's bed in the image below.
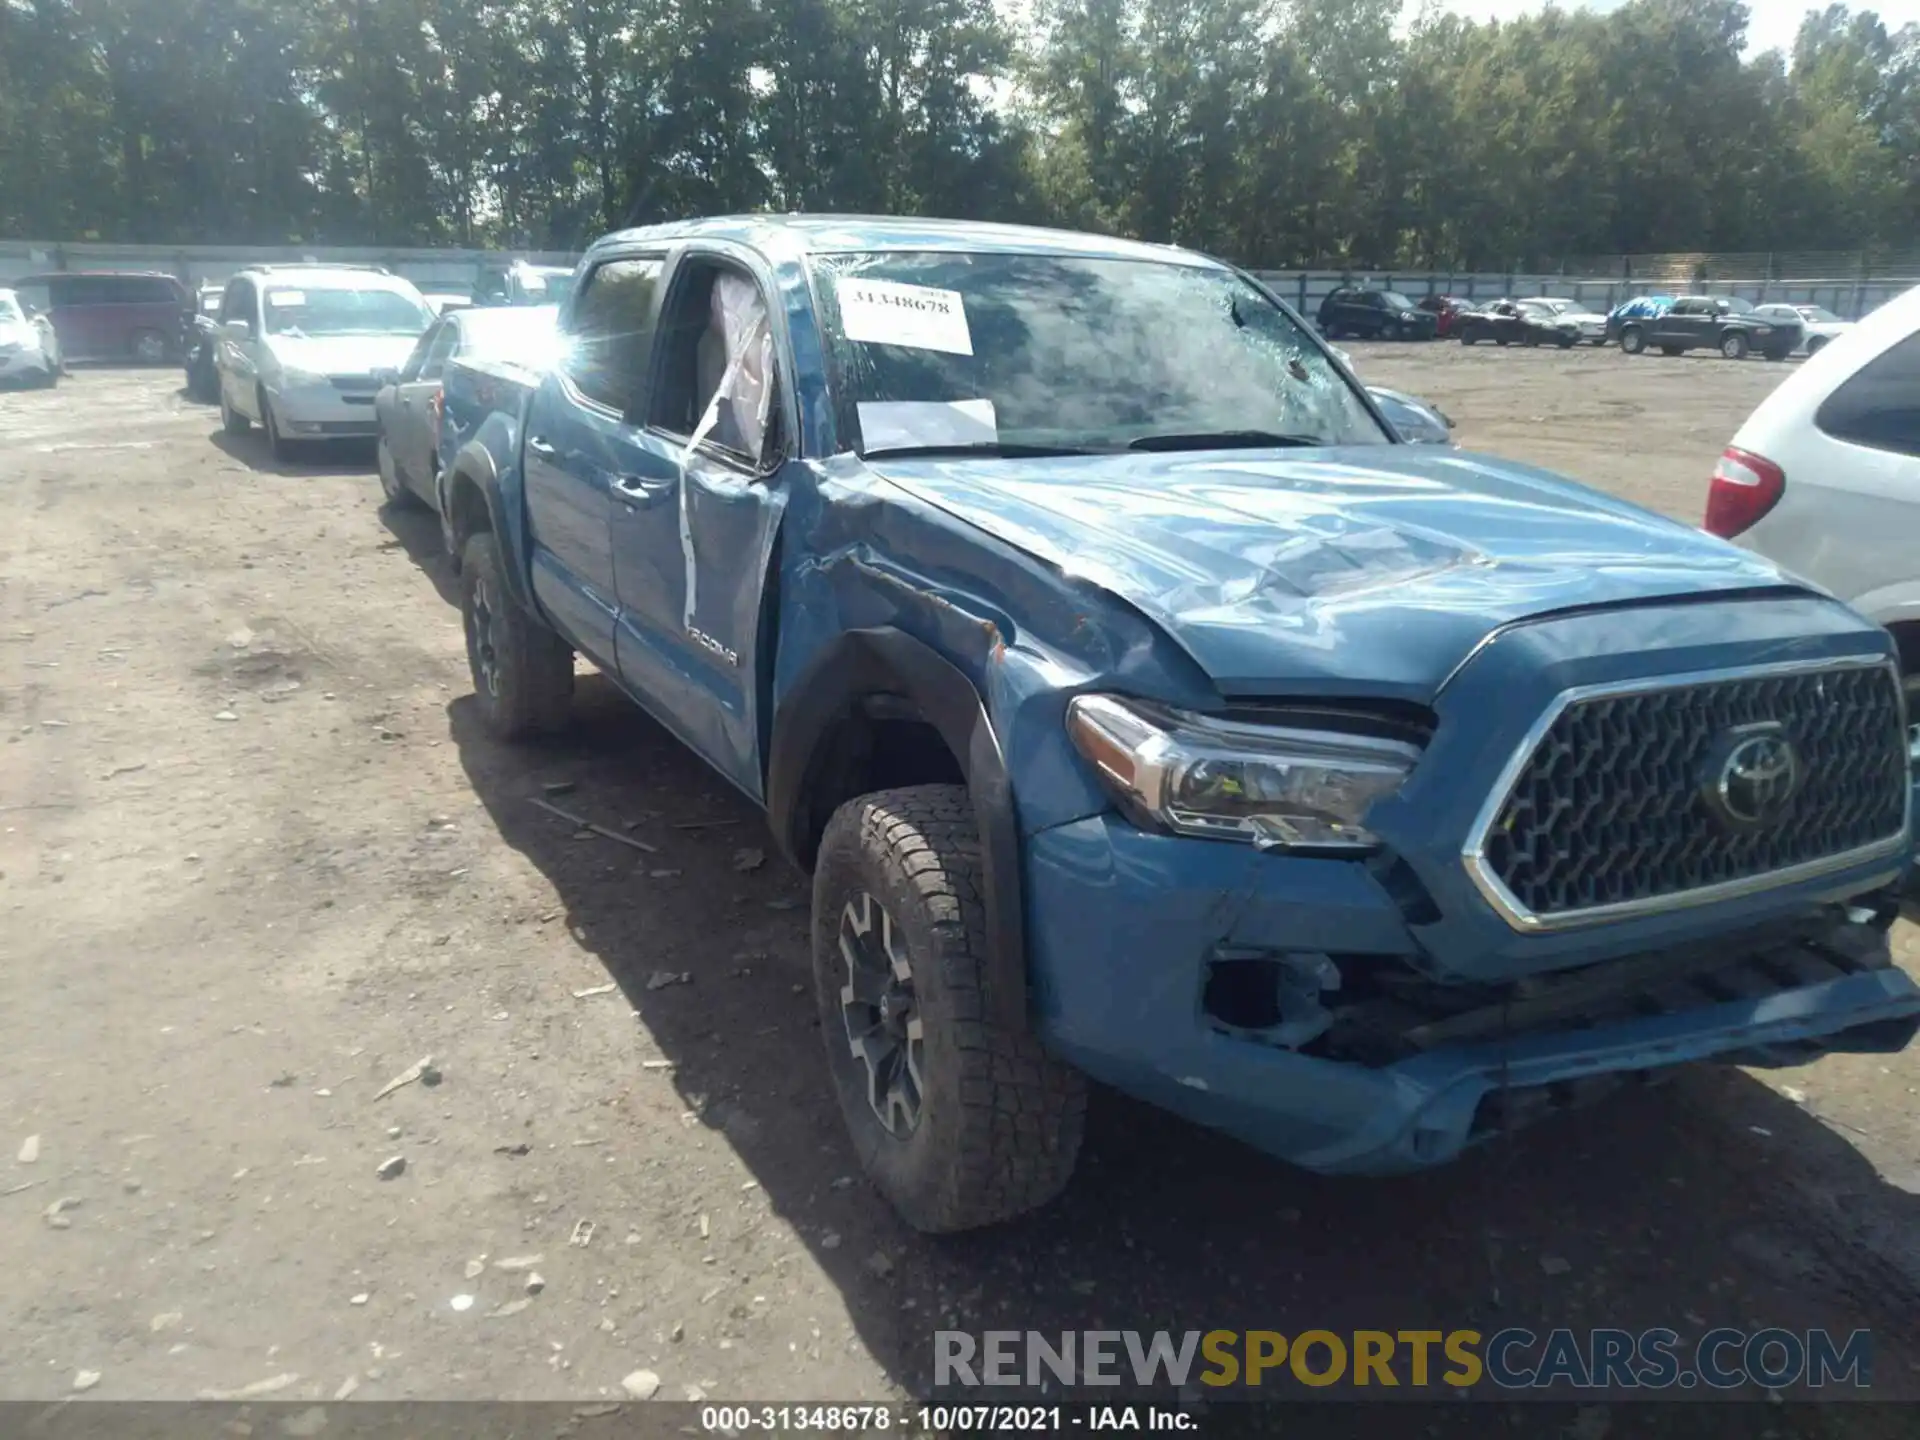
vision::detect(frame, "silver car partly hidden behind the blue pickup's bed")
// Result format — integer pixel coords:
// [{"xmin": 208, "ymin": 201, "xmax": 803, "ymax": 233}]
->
[{"xmin": 372, "ymin": 305, "xmax": 559, "ymax": 509}]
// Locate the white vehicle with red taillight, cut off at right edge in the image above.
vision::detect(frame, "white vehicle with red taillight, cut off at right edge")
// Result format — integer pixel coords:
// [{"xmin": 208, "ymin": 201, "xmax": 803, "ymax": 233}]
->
[{"xmin": 1705, "ymin": 288, "xmax": 1920, "ymax": 721}]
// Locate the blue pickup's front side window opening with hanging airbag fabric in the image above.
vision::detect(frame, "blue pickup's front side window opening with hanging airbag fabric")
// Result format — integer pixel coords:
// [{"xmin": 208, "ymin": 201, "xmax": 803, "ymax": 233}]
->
[{"xmin": 649, "ymin": 261, "xmax": 778, "ymax": 468}]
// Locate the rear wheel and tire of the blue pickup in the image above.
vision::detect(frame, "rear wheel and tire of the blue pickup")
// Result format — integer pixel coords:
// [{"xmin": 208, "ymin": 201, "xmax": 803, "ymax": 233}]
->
[{"xmin": 461, "ymin": 530, "xmax": 574, "ymax": 739}]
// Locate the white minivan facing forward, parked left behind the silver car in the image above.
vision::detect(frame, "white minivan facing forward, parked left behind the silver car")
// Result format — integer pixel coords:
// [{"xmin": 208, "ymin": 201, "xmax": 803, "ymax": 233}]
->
[{"xmin": 215, "ymin": 265, "xmax": 434, "ymax": 459}]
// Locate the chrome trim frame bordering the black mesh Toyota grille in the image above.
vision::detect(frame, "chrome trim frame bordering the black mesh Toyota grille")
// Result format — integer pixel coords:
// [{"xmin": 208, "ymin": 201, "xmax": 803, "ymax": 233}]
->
[{"xmin": 1461, "ymin": 655, "xmax": 1912, "ymax": 933}]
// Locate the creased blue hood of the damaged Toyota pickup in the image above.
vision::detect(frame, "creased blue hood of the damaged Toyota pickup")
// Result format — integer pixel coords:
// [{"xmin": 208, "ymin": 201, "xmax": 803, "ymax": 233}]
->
[{"xmin": 872, "ymin": 445, "xmax": 1797, "ymax": 699}]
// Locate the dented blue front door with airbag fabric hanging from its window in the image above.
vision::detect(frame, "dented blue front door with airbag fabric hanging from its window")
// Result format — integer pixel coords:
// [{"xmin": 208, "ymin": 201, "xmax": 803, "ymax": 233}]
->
[{"xmin": 611, "ymin": 250, "xmax": 787, "ymax": 799}]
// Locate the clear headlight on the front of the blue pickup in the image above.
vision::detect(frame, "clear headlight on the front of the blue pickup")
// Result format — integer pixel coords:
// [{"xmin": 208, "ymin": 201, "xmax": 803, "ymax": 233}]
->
[{"xmin": 1068, "ymin": 695, "xmax": 1421, "ymax": 852}]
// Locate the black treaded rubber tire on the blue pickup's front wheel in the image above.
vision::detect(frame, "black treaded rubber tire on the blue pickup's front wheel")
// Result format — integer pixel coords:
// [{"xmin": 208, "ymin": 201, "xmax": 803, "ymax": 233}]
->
[{"xmin": 814, "ymin": 785, "xmax": 1087, "ymax": 1235}]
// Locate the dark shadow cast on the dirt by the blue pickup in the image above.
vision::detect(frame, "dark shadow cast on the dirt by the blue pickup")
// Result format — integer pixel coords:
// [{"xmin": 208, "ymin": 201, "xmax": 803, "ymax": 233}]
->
[{"xmin": 386, "ymin": 511, "xmax": 1920, "ymax": 1413}]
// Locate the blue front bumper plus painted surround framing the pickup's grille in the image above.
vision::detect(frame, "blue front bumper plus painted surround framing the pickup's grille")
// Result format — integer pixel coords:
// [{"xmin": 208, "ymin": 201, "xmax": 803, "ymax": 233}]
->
[{"xmin": 1016, "ymin": 595, "xmax": 1920, "ymax": 1171}]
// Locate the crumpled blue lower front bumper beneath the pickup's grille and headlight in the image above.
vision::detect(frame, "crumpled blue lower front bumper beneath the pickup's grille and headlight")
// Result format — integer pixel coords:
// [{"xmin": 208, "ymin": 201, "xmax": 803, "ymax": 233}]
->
[{"xmin": 1027, "ymin": 814, "xmax": 1920, "ymax": 1173}]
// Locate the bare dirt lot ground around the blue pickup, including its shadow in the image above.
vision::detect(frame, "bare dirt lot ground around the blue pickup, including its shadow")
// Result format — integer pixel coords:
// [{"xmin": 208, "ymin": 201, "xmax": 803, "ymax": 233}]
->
[{"xmin": 0, "ymin": 355, "xmax": 1920, "ymax": 1432}]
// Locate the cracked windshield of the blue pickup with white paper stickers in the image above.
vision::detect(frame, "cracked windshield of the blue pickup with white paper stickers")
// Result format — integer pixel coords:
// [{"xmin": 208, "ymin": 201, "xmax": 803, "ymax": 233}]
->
[{"xmin": 812, "ymin": 252, "xmax": 1392, "ymax": 453}]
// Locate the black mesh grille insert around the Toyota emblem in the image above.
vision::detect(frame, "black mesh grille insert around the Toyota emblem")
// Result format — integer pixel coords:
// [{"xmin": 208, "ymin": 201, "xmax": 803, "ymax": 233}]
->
[{"xmin": 1484, "ymin": 666, "xmax": 1908, "ymax": 916}]
